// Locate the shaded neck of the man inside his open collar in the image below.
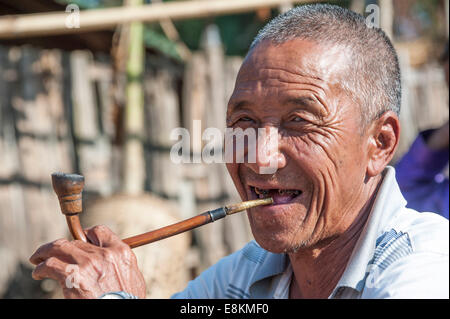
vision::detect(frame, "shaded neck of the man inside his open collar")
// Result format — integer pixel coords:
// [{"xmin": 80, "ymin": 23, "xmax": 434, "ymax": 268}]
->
[{"xmin": 288, "ymin": 174, "xmax": 382, "ymax": 298}]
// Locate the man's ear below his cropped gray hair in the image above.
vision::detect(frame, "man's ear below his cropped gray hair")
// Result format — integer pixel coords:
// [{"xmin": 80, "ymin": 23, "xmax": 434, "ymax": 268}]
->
[{"xmin": 367, "ymin": 111, "xmax": 400, "ymax": 177}]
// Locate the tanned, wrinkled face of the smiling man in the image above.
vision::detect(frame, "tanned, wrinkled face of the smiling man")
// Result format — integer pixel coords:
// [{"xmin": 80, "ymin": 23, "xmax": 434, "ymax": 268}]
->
[{"xmin": 227, "ymin": 39, "xmax": 367, "ymax": 252}]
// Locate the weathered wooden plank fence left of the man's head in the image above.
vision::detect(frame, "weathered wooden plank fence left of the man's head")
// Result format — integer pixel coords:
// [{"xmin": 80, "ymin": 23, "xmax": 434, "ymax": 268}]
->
[{"xmin": 0, "ymin": 30, "xmax": 251, "ymax": 297}]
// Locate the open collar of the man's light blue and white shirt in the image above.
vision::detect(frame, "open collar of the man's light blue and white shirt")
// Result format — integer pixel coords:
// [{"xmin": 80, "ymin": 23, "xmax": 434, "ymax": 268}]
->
[{"xmin": 250, "ymin": 166, "xmax": 406, "ymax": 297}]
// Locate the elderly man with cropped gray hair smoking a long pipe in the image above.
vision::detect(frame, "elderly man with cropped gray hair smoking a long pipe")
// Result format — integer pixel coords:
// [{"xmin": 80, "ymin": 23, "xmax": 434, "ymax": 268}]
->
[{"xmin": 30, "ymin": 5, "xmax": 449, "ymax": 298}]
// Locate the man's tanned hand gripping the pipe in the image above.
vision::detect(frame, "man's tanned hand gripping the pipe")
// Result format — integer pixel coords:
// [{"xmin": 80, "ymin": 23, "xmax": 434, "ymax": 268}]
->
[{"xmin": 30, "ymin": 226, "xmax": 145, "ymax": 298}]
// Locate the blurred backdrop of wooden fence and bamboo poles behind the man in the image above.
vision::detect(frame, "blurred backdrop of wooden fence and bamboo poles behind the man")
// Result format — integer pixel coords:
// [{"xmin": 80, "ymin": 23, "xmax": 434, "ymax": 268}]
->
[{"xmin": 0, "ymin": 0, "xmax": 449, "ymax": 298}]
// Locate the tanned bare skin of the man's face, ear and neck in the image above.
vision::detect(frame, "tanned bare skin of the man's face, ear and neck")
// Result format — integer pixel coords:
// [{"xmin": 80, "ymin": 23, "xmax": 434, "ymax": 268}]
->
[{"xmin": 227, "ymin": 39, "xmax": 400, "ymax": 298}]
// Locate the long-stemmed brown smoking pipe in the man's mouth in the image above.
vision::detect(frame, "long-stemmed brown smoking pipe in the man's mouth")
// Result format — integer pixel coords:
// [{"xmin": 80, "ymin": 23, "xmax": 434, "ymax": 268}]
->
[{"xmin": 52, "ymin": 173, "xmax": 273, "ymax": 248}]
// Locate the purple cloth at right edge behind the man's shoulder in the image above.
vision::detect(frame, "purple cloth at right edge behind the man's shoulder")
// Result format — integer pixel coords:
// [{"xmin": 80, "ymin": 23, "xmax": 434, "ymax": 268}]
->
[{"xmin": 395, "ymin": 131, "xmax": 449, "ymax": 219}]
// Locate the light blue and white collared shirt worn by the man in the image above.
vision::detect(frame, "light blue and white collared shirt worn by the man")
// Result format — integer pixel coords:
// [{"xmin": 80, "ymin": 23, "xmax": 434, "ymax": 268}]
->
[{"xmin": 172, "ymin": 167, "xmax": 449, "ymax": 299}]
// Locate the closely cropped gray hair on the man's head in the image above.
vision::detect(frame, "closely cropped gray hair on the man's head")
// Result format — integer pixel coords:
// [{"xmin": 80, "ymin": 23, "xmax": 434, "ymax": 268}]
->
[{"xmin": 250, "ymin": 4, "xmax": 401, "ymax": 126}]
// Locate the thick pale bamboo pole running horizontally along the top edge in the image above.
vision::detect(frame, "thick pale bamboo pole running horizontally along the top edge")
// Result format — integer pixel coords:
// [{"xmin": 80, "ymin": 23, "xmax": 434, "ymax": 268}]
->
[{"xmin": 0, "ymin": 0, "xmax": 320, "ymax": 39}]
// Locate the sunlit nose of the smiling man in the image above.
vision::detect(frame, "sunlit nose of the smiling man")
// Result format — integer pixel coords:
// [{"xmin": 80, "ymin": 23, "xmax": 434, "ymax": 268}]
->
[{"xmin": 245, "ymin": 127, "xmax": 287, "ymax": 174}]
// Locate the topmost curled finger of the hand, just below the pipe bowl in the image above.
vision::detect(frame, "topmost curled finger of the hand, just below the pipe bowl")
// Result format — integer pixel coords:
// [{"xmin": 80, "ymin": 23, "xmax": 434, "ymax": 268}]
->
[{"xmin": 30, "ymin": 239, "xmax": 86, "ymax": 265}]
